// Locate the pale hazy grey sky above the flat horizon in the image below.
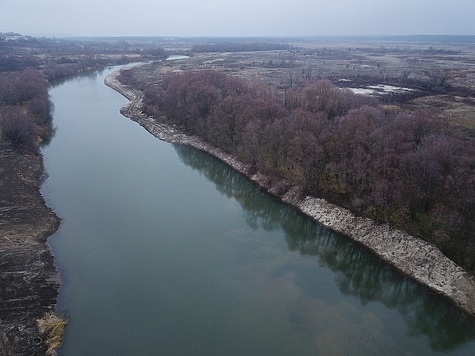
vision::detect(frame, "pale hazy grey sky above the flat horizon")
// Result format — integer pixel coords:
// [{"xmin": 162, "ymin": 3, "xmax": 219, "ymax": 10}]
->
[{"xmin": 0, "ymin": 0, "xmax": 475, "ymax": 36}]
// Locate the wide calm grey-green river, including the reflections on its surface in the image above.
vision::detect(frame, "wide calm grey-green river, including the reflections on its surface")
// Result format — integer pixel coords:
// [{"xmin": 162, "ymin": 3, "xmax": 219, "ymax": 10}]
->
[{"xmin": 43, "ymin": 69, "xmax": 475, "ymax": 356}]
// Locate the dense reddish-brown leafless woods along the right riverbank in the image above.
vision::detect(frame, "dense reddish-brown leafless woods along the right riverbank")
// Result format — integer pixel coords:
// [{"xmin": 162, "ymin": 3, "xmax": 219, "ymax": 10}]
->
[{"xmin": 132, "ymin": 71, "xmax": 475, "ymax": 271}]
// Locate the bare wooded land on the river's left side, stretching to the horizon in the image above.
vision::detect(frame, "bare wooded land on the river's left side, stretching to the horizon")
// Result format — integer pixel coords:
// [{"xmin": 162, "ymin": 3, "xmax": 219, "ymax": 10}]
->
[{"xmin": 0, "ymin": 33, "xmax": 166, "ymax": 153}]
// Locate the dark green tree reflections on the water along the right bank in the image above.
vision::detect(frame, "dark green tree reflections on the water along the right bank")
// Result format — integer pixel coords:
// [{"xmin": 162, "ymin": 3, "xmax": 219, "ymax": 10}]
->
[{"xmin": 174, "ymin": 145, "xmax": 475, "ymax": 351}]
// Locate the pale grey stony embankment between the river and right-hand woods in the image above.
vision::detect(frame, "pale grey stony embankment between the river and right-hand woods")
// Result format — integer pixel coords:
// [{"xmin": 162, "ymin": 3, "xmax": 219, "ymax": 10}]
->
[{"xmin": 105, "ymin": 72, "xmax": 475, "ymax": 316}]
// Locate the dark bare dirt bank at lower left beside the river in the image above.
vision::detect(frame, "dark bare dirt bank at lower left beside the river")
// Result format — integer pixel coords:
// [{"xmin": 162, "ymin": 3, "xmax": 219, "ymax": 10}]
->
[{"xmin": 0, "ymin": 145, "xmax": 64, "ymax": 355}]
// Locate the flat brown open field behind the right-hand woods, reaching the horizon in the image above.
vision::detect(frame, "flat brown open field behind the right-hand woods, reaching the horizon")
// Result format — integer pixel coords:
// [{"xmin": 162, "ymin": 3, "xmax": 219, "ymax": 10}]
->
[{"xmin": 132, "ymin": 40, "xmax": 475, "ymax": 137}]
